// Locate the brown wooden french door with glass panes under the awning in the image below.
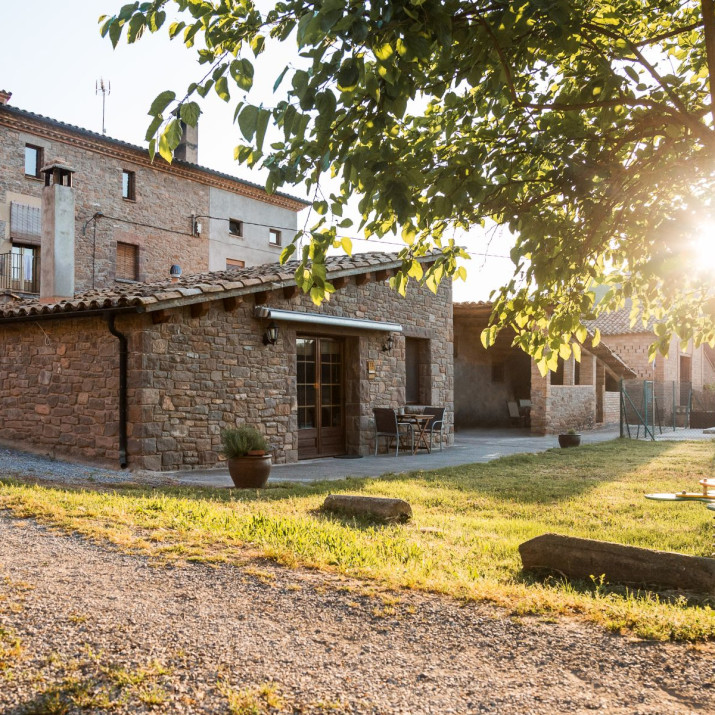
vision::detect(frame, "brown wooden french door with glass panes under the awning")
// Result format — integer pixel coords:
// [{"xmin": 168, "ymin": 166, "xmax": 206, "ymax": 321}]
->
[{"xmin": 297, "ymin": 336, "xmax": 345, "ymax": 459}]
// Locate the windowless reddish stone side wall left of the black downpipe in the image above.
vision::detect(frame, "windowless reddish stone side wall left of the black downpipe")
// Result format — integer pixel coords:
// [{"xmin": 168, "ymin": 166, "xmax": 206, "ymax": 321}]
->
[{"xmin": 0, "ymin": 318, "xmax": 129, "ymax": 468}]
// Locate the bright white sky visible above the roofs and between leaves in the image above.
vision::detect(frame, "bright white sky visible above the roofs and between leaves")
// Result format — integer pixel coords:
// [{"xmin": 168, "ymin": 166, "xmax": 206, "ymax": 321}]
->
[{"xmin": 0, "ymin": 0, "xmax": 513, "ymax": 301}]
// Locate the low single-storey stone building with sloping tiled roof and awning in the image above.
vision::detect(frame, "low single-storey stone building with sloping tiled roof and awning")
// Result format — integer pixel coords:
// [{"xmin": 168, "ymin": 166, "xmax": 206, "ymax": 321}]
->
[{"xmin": 0, "ymin": 254, "xmax": 454, "ymax": 470}]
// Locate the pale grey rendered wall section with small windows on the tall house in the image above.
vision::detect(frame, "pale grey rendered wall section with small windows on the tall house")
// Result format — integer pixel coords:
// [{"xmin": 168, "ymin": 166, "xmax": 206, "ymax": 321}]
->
[{"xmin": 207, "ymin": 188, "xmax": 298, "ymax": 271}]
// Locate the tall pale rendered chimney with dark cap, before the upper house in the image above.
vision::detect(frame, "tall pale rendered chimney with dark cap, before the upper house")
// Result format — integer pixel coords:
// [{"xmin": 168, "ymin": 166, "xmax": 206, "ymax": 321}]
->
[{"xmin": 40, "ymin": 159, "xmax": 74, "ymax": 302}]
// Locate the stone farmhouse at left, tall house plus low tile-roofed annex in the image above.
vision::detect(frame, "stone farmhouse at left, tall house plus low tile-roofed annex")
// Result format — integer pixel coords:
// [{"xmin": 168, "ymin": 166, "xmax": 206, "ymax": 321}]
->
[{"xmin": 0, "ymin": 93, "xmax": 454, "ymax": 469}]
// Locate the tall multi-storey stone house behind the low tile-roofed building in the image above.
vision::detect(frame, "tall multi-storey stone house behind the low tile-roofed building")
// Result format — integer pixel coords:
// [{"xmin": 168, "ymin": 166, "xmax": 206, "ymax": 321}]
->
[{"xmin": 0, "ymin": 92, "xmax": 307, "ymax": 296}]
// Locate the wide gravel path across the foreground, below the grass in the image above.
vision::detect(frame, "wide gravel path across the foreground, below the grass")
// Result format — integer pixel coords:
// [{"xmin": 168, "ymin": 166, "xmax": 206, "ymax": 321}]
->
[{"xmin": 0, "ymin": 512, "xmax": 715, "ymax": 715}]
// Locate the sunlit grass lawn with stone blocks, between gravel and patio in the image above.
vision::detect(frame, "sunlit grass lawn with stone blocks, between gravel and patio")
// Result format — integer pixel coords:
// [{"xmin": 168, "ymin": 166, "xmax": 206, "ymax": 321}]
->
[{"xmin": 0, "ymin": 440, "xmax": 715, "ymax": 640}]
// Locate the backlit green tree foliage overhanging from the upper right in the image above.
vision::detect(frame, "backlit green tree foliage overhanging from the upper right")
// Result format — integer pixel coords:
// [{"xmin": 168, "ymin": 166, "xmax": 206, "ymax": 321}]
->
[{"xmin": 100, "ymin": 0, "xmax": 715, "ymax": 369}]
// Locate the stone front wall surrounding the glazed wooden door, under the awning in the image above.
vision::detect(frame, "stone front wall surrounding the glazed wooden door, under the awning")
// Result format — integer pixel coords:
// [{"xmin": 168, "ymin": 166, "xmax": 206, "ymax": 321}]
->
[{"xmin": 127, "ymin": 280, "xmax": 453, "ymax": 469}]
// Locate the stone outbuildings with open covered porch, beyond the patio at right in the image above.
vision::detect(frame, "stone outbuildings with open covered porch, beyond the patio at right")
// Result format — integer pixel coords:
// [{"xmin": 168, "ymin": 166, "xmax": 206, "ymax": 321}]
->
[{"xmin": 454, "ymin": 302, "xmax": 715, "ymax": 434}]
